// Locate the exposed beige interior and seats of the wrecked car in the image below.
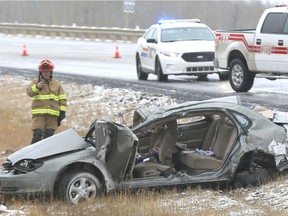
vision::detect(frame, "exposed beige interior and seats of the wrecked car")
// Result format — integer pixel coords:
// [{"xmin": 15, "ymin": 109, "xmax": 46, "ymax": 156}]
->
[{"xmin": 133, "ymin": 111, "xmax": 237, "ymax": 178}]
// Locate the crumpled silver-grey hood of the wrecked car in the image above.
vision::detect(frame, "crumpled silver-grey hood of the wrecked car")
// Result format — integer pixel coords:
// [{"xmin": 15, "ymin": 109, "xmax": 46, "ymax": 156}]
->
[{"xmin": 8, "ymin": 129, "xmax": 90, "ymax": 164}]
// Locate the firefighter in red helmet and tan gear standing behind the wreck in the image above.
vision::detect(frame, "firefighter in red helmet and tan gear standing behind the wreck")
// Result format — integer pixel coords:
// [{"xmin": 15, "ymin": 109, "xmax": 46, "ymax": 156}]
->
[{"xmin": 27, "ymin": 60, "xmax": 67, "ymax": 144}]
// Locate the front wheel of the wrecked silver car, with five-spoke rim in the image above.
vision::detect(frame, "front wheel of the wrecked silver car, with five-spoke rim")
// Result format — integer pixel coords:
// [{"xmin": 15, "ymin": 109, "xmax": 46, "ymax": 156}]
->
[{"xmin": 58, "ymin": 171, "xmax": 101, "ymax": 204}]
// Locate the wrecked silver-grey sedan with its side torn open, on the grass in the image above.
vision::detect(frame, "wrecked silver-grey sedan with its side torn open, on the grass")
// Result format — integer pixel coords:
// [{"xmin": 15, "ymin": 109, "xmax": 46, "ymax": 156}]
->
[{"xmin": 0, "ymin": 97, "xmax": 288, "ymax": 204}]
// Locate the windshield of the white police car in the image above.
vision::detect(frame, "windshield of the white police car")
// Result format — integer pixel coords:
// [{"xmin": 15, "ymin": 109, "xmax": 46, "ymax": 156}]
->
[{"xmin": 161, "ymin": 27, "xmax": 214, "ymax": 42}]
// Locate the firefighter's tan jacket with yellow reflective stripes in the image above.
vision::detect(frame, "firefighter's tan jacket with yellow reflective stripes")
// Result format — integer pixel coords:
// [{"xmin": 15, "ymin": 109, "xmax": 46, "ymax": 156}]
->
[{"xmin": 27, "ymin": 78, "xmax": 67, "ymax": 117}]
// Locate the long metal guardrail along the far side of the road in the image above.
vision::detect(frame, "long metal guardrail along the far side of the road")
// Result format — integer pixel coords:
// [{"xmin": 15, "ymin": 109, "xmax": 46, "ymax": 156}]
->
[{"xmin": 0, "ymin": 23, "xmax": 145, "ymax": 42}]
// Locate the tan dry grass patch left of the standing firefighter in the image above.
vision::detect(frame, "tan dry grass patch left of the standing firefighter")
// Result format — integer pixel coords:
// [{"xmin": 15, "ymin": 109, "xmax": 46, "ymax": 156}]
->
[{"xmin": 0, "ymin": 77, "xmax": 32, "ymax": 150}]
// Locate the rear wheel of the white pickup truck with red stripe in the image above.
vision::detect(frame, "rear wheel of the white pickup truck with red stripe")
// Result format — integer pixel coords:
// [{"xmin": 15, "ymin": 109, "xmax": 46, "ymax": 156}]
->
[{"xmin": 229, "ymin": 59, "xmax": 255, "ymax": 92}]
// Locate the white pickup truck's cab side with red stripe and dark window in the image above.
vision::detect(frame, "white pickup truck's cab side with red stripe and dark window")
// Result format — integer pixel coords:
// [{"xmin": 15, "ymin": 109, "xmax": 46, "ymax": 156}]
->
[{"xmin": 254, "ymin": 12, "xmax": 288, "ymax": 74}]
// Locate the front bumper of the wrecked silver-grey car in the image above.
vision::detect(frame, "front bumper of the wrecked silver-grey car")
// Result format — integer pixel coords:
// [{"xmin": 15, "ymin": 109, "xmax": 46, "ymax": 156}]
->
[{"xmin": 0, "ymin": 170, "xmax": 56, "ymax": 195}]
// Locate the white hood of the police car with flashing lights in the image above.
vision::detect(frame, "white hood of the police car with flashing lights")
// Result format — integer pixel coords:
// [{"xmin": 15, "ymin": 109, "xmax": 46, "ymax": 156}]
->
[{"xmin": 159, "ymin": 40, "xmax": 215, "ymax": 53}]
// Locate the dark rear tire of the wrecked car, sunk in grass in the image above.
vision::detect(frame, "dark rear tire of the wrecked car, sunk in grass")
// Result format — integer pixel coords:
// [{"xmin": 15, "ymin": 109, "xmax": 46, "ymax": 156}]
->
[{"xmin": 233, "ymin": 168, "xmax": 272, "ymax": 187}]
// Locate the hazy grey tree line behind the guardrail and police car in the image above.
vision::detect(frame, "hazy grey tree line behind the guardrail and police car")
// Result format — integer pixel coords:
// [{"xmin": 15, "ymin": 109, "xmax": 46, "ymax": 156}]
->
[{"xmin": 0, "ymin": 0, "xmax": 273, "ymax": 30}]
